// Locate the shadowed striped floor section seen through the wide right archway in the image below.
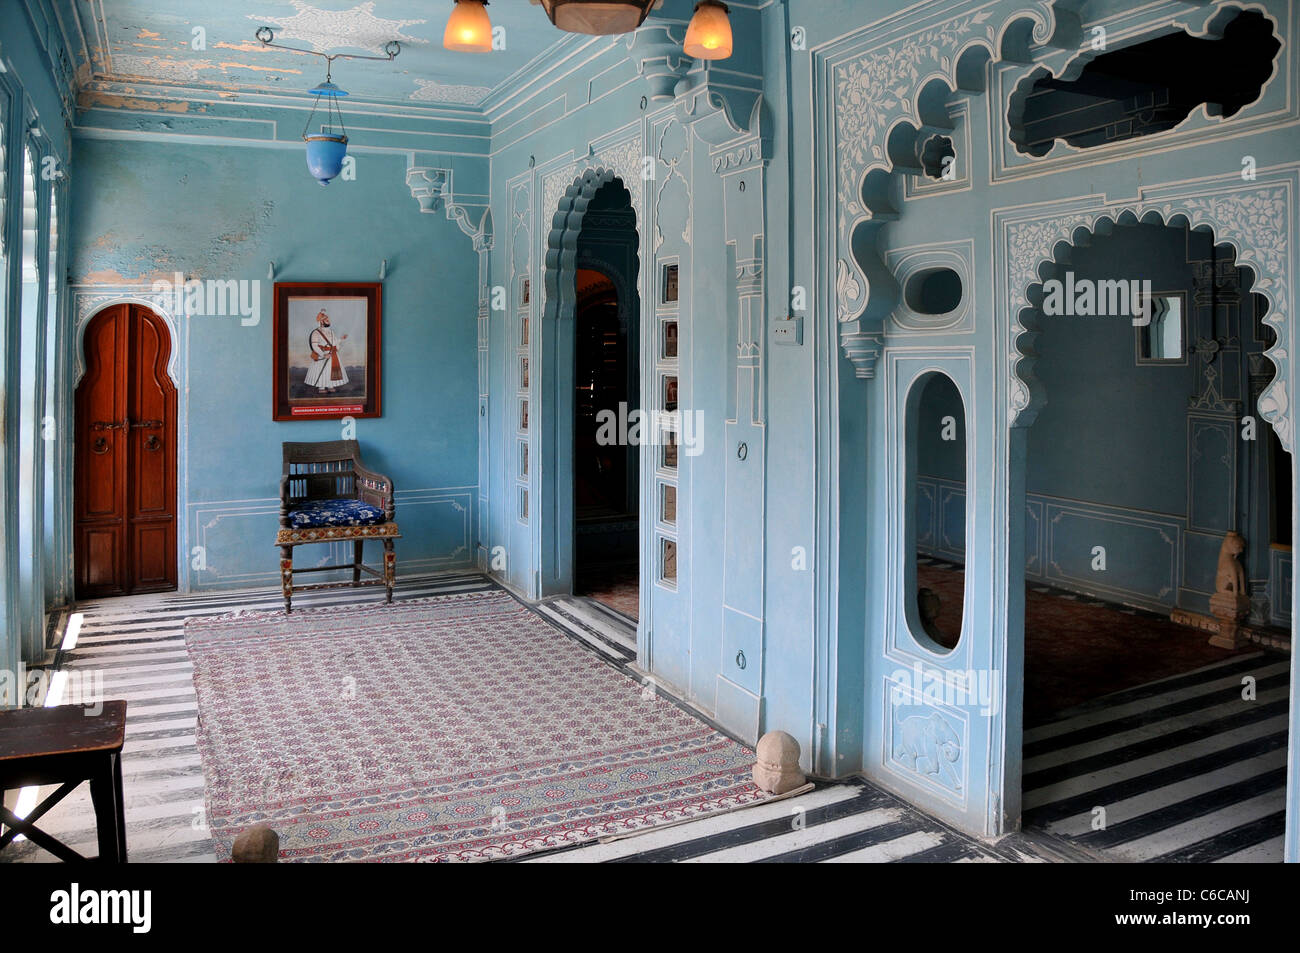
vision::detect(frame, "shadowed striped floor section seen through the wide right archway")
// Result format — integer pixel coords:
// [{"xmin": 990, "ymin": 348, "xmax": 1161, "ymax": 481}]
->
[{"xmin": 1023, "ymin": 653, "xmax": 1291, "ymax": 862}]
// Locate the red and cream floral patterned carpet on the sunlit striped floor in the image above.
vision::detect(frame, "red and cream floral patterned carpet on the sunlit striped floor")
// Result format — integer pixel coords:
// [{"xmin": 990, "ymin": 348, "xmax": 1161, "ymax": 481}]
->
[{"xmin": 186, "ymin": 592, "xmax": 767, "ymax": 862}]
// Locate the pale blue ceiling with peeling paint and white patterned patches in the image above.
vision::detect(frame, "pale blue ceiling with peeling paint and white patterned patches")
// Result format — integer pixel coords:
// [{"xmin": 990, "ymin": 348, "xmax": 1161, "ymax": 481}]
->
[{"xmin": 73, "ymin": 0, "xmax": 613, "ymax": 107}]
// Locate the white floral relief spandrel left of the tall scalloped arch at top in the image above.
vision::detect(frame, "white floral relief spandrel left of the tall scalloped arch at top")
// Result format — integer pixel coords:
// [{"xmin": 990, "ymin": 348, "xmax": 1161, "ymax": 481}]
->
[{"xmin": 814, "ymin": 0, "xmax": 1060, "ymax": 378}]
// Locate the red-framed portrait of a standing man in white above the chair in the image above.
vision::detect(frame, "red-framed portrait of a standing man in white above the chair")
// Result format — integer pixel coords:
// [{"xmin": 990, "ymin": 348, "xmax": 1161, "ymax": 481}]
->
[{"xmin": 270, "ymin": 281, "xmax": 384, "ymax": 420}]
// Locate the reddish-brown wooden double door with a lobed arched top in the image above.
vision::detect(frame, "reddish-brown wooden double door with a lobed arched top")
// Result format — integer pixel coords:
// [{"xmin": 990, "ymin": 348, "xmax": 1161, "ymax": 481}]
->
[{"xmin": 74, "ymin": 304, "xmax": 177, "ymax": 598}]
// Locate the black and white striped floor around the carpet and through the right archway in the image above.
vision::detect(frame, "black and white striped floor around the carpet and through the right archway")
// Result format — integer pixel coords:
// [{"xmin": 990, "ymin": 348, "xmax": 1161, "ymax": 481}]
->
[{"xmin": 0, "ymin": 573, "xmax": 1287, "ymax": 863}]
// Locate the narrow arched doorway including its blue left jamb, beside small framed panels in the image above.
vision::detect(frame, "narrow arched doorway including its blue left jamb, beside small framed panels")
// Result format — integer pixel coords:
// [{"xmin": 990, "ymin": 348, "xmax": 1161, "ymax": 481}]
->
[{"xmin": 534, "ymin": 169, "xmax": 642, "ymax": 605}]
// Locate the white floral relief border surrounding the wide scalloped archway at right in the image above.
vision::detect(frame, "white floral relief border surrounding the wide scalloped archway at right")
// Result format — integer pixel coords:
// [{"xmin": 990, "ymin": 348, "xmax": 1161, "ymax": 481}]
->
[{"xmin": 995, "ymin": 170, "xmax": 1300, "ymax": 452}]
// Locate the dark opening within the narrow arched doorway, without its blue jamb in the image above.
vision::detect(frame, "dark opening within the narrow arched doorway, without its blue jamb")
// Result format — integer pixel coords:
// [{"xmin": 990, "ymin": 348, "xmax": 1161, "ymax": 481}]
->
[{"xmin": 573, "ymin": 179, "xmax": 641, "ymax": 619}]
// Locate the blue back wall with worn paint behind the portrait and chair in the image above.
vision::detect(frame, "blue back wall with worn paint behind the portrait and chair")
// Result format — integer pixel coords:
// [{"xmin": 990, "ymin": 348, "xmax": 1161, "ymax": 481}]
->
[{"xmin": 72, "ymin": 138, "xmax": 477, "ymax": 589}]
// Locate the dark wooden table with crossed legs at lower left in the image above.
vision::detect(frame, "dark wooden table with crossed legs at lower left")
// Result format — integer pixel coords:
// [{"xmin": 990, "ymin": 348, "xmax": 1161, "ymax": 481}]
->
[{"xmin": 0, "ymin": 701, "xmax": 126, "ymax": 863}]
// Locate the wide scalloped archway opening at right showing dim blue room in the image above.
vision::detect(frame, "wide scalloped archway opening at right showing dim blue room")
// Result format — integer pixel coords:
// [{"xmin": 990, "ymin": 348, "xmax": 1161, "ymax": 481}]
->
[{"xmin": 1009, "ymin": 215, "xmax": 1291, "ymax": 861}]
